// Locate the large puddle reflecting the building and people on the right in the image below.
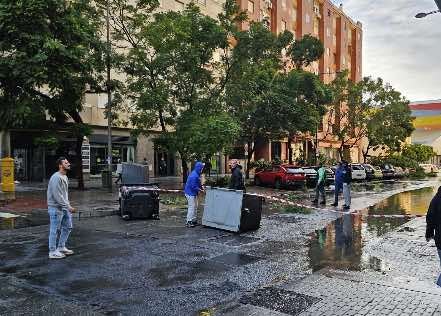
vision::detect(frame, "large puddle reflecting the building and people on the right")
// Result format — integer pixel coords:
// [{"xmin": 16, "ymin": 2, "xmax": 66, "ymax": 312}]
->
[{"xmin": 309, "ymin": 188, "xmax": 436, "ymax": 271}]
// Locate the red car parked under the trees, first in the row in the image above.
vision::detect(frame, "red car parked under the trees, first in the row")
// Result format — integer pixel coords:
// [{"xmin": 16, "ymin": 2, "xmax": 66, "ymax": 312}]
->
[{"xmin": 254, "ymin": 165, "xmax": 306, "ymax": 189}]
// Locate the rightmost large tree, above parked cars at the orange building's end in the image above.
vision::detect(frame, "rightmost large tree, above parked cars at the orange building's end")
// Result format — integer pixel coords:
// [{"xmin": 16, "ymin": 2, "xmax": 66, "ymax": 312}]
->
[{"xmin": 325, "ymin": 71, "xmax": 413, "ymax": 161}]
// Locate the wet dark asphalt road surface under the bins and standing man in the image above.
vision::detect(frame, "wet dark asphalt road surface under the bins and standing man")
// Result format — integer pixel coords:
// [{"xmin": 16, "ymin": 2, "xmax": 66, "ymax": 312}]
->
[{"xmin": 0, "ymin": 179, "xmax": 440, "ymax": 315}]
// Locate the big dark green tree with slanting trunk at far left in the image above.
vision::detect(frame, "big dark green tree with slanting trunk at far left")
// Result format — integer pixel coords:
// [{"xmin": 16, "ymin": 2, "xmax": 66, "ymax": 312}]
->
[{"xmin": 0, "ymin": 0, "xmax": 104, "ymax": 189}]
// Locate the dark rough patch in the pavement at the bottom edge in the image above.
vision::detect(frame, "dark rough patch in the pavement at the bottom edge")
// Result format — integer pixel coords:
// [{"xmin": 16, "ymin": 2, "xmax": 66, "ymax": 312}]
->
[{"xmin": 240, "ymin": 287, "xmax": 321, "ymax": 315}]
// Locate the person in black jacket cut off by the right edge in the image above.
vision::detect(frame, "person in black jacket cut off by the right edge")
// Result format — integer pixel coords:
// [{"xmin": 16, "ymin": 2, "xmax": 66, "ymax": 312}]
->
[{"xmin": 426, "ymin": 187, "xmax": 441, "ymax": 286}]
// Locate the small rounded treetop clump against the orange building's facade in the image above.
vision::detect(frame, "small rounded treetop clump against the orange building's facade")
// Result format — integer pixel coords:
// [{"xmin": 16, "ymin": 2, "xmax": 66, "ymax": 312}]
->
[{"xmin": 288, "ymin": 35, "xmax": 325, "ymax": 69}]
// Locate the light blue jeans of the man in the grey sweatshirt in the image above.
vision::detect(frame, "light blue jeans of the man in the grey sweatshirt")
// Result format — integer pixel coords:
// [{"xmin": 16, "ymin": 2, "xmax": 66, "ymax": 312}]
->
[{"xmin": 48, "ymin": 206, "xmax": 73, "ymax": 252}]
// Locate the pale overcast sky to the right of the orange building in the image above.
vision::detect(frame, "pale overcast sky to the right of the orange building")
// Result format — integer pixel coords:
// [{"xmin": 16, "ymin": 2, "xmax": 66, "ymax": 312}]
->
[{"xmin": 334, "ymin": 0, "xmax": 441, "ymax": 101}]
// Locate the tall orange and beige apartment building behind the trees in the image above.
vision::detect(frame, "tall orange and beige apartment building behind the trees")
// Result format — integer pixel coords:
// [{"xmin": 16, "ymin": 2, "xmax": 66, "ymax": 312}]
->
[{"xmin": 237, "ymin": 0, "xmax": 363, "ymax": 162}]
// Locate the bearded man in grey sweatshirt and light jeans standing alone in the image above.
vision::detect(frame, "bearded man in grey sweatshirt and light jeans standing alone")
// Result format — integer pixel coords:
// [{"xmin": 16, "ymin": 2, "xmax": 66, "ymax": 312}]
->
[{"xmin": 47, "ymin": 157, "xmax": 75, "ymax": 259}]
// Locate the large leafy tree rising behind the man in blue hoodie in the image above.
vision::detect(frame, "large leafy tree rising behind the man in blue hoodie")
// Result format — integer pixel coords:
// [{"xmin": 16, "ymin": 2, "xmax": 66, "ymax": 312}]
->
[{"xmin": 106, "ymin": 0, "xmax": 242, "ymax": 181}]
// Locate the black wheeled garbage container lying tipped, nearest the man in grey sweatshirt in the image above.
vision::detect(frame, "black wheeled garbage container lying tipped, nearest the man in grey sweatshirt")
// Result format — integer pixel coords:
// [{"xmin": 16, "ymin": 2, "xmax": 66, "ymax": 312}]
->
[{"xmin": 119, "ymin": 184, "xmax": 159, "ymax": 219}]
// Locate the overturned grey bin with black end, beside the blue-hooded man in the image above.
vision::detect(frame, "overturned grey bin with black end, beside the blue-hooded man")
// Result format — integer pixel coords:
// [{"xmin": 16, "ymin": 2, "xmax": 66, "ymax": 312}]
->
[{"xmin": 202, "ymin": 187, "xmax": 263, "ymax": 232}]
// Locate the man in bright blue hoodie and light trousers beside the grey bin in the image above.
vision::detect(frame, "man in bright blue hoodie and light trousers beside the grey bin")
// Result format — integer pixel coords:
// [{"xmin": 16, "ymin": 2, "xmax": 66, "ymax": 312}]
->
[{"xmin": 184, "ymin": 161, "xmax": 204, "ymax": 227}]
